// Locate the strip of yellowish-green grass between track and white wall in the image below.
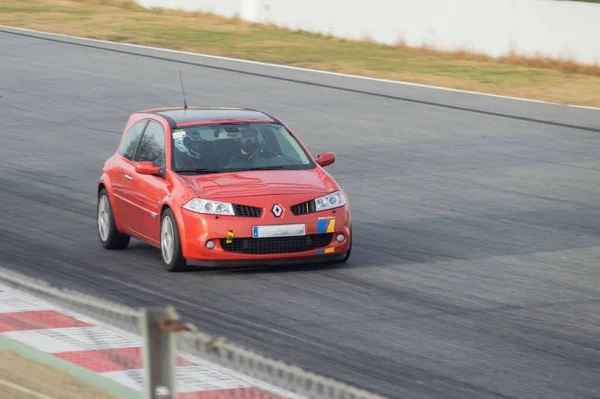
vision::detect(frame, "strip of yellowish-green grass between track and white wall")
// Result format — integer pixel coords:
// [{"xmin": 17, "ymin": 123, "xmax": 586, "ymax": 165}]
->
[{"xmin": 0, "ymin": 0, "xmax": 600, "ymax": 107}]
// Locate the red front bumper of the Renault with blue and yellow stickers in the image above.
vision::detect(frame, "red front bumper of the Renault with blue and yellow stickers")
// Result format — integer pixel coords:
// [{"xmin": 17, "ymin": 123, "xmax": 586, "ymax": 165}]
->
[{"xmin": 179, "ymin": 197, "xmax": 351, "ymax": 265}]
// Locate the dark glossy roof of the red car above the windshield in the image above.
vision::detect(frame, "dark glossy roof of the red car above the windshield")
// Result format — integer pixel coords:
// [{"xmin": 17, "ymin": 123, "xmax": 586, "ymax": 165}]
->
[{"xmin": 137, "ymin": 107, "xmax": 279, "ymax": 128}]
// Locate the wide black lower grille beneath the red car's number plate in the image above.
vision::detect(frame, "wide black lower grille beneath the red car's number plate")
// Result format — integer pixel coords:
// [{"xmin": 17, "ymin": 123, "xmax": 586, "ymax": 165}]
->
[{"xmin": 220, "ymin": 233, "xmax": 333, "ymax": 255}]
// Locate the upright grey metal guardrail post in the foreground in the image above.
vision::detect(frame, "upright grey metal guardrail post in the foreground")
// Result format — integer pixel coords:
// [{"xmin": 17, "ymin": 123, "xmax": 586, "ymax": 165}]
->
[{"xmin": 140, "ymin": 307, "xmax": 179, "ymax": 399}]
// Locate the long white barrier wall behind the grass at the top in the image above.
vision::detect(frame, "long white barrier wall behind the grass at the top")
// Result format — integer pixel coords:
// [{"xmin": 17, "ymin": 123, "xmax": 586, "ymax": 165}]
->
[{"xmin": 136, "ymin": 0, "xmax": 600, "ymax": 65}]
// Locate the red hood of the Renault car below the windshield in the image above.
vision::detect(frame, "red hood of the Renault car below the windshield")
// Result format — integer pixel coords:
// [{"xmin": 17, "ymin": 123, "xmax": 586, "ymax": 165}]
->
[{"xmin": 180, "ymin": 168, "xmax": 338, "ymax": 199}]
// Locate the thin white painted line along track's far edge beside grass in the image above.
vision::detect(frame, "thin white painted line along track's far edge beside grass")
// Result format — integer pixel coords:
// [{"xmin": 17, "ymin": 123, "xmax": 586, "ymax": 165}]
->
[{"xmin": 0, "ymin": 25, "xmax": 600, "ymax": 111}]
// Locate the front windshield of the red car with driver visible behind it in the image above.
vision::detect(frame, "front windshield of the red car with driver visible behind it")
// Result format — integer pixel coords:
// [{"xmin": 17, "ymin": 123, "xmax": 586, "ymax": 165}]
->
[{"xmin": 172, "ymin": 122, "xmax": 315, "ymax": 173}]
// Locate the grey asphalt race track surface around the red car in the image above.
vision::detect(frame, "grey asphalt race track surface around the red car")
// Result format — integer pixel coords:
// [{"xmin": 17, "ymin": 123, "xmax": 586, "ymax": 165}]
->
[{"xmin": 0, "ymin": 30, "xmax": 600, "ymax": 399}]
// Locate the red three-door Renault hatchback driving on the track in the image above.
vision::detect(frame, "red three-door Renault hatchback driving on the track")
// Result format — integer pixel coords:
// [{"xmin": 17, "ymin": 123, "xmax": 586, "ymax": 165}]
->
[{"xmin": 97, "ymin": 107, "xmax": 352, "ymax": 271}]
